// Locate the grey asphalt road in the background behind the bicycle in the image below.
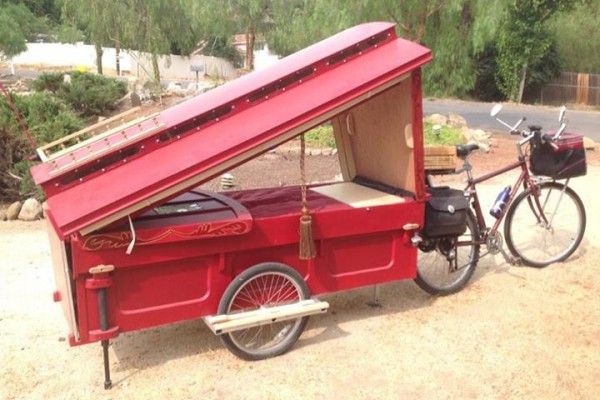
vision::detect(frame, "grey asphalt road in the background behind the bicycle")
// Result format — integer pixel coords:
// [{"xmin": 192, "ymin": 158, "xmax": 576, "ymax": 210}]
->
[{"xmin": 423, "ymin": 99, "xmax": 600, "ymax": 142}]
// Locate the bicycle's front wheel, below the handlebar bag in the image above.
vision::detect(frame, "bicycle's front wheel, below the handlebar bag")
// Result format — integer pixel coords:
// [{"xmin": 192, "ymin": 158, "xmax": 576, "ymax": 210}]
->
[{"xmin": 504, "ymin": 182, "xmax": 586, "ymax": 268}]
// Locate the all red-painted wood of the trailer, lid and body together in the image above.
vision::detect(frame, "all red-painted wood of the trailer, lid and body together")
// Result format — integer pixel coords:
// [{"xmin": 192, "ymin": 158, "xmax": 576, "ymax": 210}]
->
[{"xmin": 42, "ymin": 23, "xmax": 431, "ymax": 345}]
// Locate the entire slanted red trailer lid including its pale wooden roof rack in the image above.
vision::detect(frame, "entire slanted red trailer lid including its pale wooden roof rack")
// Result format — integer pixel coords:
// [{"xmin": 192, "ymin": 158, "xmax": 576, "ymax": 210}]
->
[{"xmin": 32, "ymin": 22, "xmax": 431, "ymax": 237}]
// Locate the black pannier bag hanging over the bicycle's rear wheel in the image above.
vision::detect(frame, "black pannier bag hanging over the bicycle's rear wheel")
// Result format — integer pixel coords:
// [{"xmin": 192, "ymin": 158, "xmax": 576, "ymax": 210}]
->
[{"xmin": 423, "ymin": 186, "xmax": 469, "ymax": 238}]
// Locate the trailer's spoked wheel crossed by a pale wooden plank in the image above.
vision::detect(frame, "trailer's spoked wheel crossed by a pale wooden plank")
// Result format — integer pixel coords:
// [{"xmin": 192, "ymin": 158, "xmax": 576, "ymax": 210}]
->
[{"xmin": 219, "ymin": 263, "xmax": 310, "ymax": 360}]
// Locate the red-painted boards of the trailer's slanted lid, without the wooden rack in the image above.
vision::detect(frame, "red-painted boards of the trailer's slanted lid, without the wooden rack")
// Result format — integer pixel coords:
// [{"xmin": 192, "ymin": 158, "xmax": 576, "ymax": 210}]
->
[{"xmin": 32, "ymin": 23, "xmax": 431, "ymax": 238}]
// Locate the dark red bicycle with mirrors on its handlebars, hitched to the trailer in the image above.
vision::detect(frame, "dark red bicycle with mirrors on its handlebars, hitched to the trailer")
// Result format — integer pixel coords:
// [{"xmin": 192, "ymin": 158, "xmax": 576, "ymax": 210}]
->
[{"xmin": 415, "ymin": 105, "xmax": 586, "ymax": 295}]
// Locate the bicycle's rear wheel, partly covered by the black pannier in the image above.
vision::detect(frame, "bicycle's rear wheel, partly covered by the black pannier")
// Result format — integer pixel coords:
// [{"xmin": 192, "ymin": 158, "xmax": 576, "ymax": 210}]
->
[{"xmin": 415, "ymin": 210, "xmax": 479, "ymax": 296}]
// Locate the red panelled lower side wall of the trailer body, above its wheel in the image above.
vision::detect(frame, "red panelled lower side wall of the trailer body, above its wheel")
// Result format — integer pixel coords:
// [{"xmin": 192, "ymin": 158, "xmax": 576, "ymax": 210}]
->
[{"xmin": 72, "ymin": 188, "xmax": 424, "ymax": 343}]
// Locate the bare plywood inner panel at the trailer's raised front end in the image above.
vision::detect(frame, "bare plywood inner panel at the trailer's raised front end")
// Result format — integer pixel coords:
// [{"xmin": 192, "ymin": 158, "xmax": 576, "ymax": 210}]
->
[{"xmin": 332, "ymin": 79, "xmax": 415, "ymax": 192}]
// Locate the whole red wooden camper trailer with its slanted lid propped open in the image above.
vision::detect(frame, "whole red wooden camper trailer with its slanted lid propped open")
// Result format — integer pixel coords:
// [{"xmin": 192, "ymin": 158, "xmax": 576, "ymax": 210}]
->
[{"xmin": 32, "ymin": 23, "xmax": 431, "ymax": 386}]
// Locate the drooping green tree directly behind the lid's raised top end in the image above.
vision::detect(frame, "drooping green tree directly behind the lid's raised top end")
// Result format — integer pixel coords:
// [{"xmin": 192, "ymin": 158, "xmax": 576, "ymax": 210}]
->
[{"xmin": 268, "ymin": 0, "xmax": 507, "ymax": 96}]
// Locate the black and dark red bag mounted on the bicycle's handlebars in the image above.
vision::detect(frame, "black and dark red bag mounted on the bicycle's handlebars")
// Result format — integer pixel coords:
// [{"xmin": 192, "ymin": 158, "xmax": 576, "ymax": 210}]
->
[{"xmin": 529, "ymin": 133, "xmax": 587, "ymax": 179}]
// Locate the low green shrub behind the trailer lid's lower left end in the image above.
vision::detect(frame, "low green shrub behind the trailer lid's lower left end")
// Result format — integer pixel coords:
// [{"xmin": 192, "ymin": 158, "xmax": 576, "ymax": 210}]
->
[{"xmin": 33, "ymin": 71, "xmax": 127, "ymax": 116}]
